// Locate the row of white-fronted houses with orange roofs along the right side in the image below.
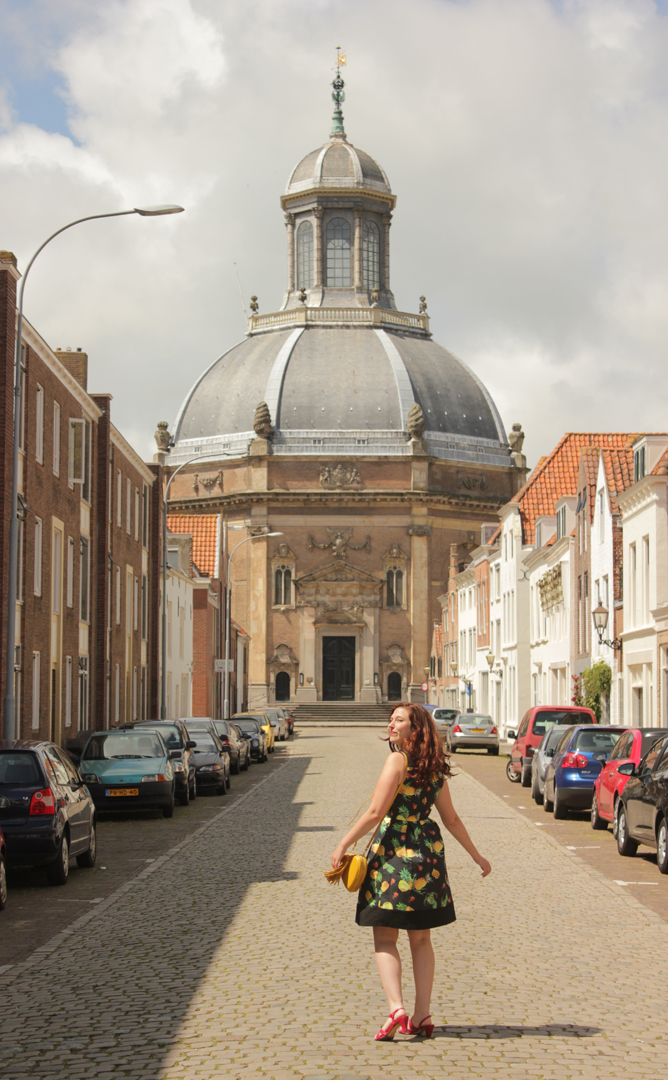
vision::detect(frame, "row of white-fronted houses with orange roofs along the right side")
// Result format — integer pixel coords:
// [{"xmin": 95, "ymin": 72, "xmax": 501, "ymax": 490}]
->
[{"xmin": 430, "ymin": 432, "xmax": 668, "ymax": 731}]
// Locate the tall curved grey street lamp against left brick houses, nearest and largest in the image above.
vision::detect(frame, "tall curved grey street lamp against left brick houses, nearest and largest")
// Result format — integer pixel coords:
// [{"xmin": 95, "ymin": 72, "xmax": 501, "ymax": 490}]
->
[{"xmin": 2, "ymin": 204, "xmax": 183, "ymax": 743}]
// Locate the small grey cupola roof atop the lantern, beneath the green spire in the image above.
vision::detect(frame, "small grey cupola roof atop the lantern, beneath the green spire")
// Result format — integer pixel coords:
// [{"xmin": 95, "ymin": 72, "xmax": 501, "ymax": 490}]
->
[{"xmin": 285, "ymin": 135, "xmax": 392, "ymax": 194}]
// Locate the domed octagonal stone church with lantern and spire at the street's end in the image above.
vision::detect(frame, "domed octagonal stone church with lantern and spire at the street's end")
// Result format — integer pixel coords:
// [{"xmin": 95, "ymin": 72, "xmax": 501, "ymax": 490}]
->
[{"xmin": 163, "ymin": 69, "xmax": 526, "ymax": 708}]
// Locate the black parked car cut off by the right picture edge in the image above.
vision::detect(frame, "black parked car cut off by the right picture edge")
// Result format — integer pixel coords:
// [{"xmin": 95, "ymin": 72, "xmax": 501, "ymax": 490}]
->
[{"xmin": 617, "ymin": 735, "xmax": 668, "ymax": 874}]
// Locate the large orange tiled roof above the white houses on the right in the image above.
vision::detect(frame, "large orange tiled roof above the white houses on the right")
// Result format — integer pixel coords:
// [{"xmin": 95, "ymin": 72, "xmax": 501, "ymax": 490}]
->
[{"xmin": 510, "ymin": 431, "xmax": 638, "ymax": 543}]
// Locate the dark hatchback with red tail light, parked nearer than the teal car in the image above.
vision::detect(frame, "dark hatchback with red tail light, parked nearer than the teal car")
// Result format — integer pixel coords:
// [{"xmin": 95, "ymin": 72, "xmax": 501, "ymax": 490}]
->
[{"xmin": 0, "ymin": 740, "xmax": 97, "ymax": 885}]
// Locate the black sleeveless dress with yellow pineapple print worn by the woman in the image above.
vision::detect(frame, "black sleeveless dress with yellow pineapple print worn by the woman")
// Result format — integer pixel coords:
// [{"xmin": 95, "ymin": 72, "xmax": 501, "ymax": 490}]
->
[{"xmin": 355, "ymin": 764, "xmax": 456, "ymax": 930}]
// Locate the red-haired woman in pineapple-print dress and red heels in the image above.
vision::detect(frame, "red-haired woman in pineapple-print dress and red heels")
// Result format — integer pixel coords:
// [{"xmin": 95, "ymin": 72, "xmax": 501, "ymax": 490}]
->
[{"xmin": 331, "ymin": 703, "xmax": 492, "ymax": 1040}]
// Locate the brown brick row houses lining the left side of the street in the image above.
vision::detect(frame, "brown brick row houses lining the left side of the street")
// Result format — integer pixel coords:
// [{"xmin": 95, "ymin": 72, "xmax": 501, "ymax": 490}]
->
[{"xmin": 0, "ymin": 252, "xmax": 161, "ymax": 742}]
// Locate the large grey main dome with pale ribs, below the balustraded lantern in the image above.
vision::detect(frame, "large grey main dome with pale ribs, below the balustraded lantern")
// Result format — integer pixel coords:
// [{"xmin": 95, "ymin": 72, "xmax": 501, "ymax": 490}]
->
[{"xmin": 175, "ymin": 326, "xmax": 506, "ymax": 453}]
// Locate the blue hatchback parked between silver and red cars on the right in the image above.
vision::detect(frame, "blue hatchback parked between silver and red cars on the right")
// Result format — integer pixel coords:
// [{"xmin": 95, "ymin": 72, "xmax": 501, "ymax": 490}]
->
[{"xmin": 543, "ymin": 724, "xmax": 626, "ymax": 818}]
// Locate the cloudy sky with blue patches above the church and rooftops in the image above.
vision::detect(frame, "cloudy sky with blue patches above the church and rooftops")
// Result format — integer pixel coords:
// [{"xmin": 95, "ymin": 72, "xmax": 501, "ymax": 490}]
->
[{"xmin": 0, "ymin": 0, "xmax": 668, "ymax": 465}]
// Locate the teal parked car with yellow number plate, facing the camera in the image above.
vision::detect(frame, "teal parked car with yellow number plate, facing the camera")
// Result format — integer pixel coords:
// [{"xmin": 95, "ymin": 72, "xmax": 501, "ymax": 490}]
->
[{"xmin": 81, "ymin": 728, "xmax": 176, "ymax": 818}]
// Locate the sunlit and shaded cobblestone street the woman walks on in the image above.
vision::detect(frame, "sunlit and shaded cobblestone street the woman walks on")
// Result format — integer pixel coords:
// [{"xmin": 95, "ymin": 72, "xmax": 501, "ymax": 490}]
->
[{"xmin": 0, "ymin": 728, "xmax": 668, "ymax": 1080}]
